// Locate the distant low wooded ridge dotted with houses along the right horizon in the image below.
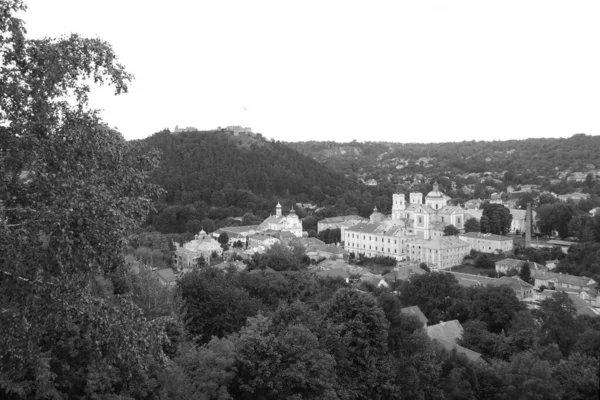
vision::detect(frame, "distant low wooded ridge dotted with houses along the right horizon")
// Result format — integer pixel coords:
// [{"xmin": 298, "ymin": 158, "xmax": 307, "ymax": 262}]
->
[{"xmin": 287, "ymin": 134, "xmax": 600, "ymax": 179}]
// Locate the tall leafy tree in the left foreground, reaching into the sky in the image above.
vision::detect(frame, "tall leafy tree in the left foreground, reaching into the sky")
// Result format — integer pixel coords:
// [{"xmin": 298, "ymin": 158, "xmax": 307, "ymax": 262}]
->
[{"xmin": 0, "ymin": 0, "xmax": 163, "ymax": 398}]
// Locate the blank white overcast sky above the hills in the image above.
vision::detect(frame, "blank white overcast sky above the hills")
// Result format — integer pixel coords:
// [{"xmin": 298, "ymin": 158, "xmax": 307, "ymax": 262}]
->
[{"xmin": 22, "ymin": 0, "xmax": 600, "ymax": 143}]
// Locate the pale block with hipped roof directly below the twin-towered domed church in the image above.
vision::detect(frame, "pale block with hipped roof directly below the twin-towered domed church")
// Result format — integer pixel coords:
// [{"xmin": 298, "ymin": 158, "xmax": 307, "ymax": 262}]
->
[{"xmin": 406, "ymin": 236, "xmax": 471, "ymax": 271}]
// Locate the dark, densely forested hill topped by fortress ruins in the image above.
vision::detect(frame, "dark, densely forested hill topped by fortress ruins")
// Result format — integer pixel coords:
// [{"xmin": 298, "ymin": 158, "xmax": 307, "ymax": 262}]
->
[{"xmin": 138, "ymin": 131, "xmax": 372, "ymax": 233}]
